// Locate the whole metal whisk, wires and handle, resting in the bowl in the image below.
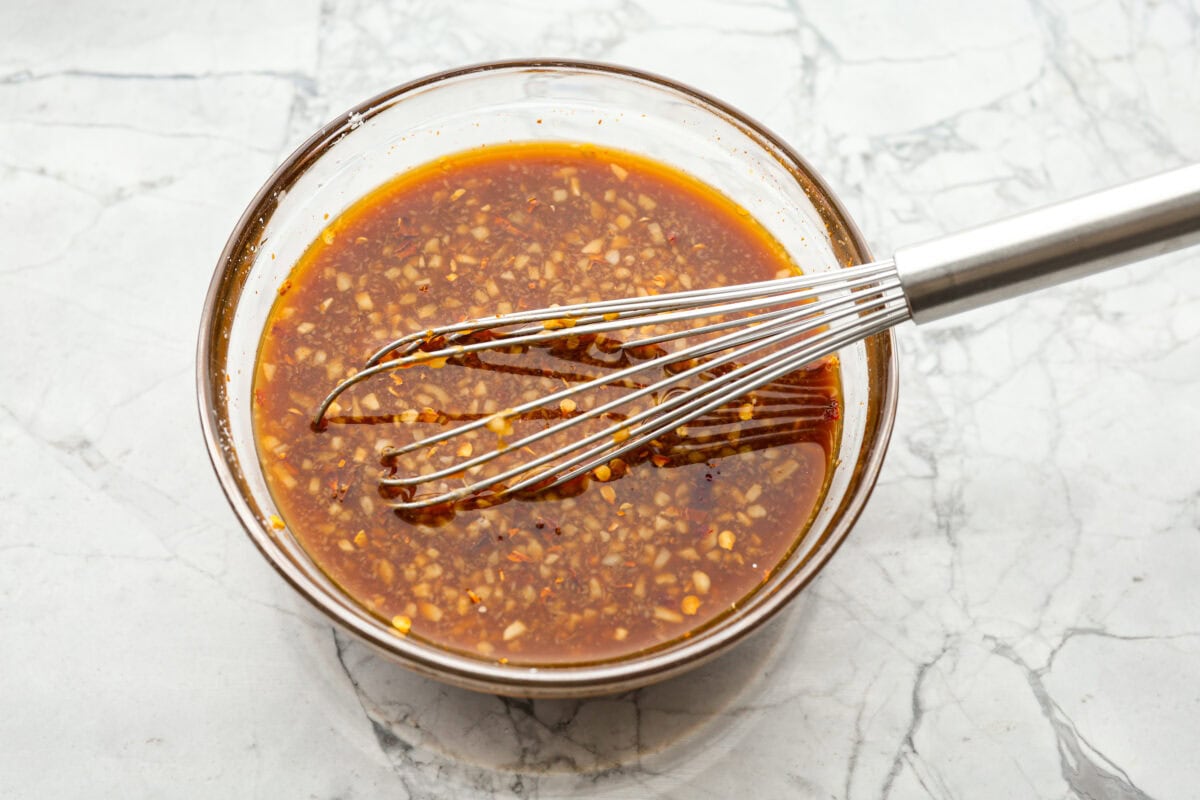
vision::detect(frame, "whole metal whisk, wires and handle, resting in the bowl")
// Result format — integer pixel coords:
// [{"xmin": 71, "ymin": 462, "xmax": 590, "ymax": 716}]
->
[{"xmin": 313, "ymin": 164, "xmax": 1200, "ymax": 510}]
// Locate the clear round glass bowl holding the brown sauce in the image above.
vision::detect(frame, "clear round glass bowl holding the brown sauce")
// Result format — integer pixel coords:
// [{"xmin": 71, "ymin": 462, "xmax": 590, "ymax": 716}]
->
[{"xmin": 197, "ymin": 60, "xmax": 896, "ymax": 697}]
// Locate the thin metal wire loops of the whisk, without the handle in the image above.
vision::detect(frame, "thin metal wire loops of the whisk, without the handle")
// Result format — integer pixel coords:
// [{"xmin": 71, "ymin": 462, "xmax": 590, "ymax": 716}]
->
[{"xmin": 313, "ymin": 261, "xmax": 910, "ymax": 510}]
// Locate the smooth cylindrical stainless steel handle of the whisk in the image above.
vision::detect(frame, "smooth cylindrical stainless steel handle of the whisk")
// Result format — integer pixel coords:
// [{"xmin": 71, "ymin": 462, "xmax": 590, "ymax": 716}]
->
[{"xmin": 894, "ymin": 164, "xmax": 1200, "ymax": 324}]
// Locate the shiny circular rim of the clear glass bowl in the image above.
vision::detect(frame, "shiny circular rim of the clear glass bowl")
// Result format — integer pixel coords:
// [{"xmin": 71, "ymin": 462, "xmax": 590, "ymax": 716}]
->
[{"xmin": 196, "ymin": 59, "xmax": 899, "ymax": 697}]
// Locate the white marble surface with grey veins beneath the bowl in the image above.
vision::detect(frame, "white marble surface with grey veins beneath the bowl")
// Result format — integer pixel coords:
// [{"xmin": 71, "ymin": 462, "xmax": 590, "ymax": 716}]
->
[{"xmin": 0, "ymin": 0, "xmax": 1200, "ymax": 800}]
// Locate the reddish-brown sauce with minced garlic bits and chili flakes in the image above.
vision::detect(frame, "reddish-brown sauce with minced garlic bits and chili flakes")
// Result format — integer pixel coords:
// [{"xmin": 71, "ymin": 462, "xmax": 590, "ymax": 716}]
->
[{"xmin": 254, "ymin": 144, "xmax": 840, "ymax": 664}]
